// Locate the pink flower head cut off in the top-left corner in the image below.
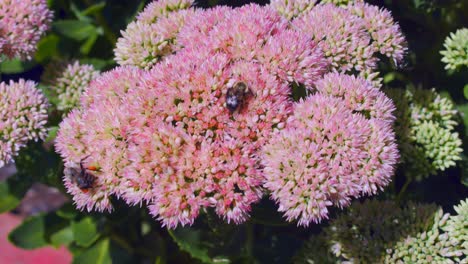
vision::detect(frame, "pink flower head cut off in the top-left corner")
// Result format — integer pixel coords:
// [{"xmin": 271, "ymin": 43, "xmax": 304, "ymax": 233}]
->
[{"xmin": 0, "ymin": 0, "xmax": 52, "ymax": 60}]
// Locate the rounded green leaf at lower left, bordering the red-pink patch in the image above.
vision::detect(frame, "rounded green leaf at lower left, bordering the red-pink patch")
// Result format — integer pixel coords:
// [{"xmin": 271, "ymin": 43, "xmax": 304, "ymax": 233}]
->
[{"xmin": 8, "ymin": 215, "xmax": 47, "ymax": 249}]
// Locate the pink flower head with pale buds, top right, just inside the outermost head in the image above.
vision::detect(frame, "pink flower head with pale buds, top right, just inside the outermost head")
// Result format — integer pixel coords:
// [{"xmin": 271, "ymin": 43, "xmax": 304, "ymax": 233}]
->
[{"xmin": 292, "ymin": 4, "xmax": 376, "ymax": 72}]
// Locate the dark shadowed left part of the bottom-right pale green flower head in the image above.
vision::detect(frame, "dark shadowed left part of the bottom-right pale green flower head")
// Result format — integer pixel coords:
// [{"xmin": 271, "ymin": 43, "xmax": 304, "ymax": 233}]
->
[{"xmin": 325, "ymin": 200, "xmax": 441, "ymax": 263}]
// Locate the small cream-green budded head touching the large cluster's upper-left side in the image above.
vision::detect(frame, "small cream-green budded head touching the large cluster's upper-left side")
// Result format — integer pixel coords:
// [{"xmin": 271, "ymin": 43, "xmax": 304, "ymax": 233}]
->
[{"xmin": 45, "ymin": 61, "xmax": 99, "ymax": 112}]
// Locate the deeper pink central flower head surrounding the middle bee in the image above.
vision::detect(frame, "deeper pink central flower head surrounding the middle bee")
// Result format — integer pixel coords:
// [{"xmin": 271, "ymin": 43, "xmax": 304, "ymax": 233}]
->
[{"xmin": 128, "ymin": 52, "xmax": 291, "ymax": 228}]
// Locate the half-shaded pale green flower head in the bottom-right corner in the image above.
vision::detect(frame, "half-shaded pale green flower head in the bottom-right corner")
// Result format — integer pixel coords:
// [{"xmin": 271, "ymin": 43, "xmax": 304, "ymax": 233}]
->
[{"xmin": 295, "ymin": 200, "xmax": 468, "ymax": 264}]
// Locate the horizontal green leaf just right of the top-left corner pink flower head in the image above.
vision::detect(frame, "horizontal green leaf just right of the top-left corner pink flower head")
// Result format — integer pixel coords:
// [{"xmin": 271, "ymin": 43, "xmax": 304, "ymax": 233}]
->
[{"xmin": 52, "ymin": 20, "xmax": 99, "ymax": 41}]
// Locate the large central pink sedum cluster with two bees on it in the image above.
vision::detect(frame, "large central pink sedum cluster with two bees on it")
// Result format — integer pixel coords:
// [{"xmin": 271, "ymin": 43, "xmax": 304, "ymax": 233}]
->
[{"xmin": 56, "ymin": 0, "xmax": 404, "ymax": 228}]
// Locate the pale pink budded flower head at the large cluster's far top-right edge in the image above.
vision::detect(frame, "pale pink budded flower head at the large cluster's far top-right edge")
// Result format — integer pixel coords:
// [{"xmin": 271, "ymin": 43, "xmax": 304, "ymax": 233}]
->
[{"xmin": 347, "ymin": 1, "xmax": 407, "ymax": 65}]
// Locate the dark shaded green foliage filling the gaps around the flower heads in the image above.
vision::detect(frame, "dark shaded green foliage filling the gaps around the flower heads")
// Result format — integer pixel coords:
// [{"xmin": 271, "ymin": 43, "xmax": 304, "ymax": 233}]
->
[{"xmin": 0, "ymin": 0, "xmax": 468, "ymax": 263}]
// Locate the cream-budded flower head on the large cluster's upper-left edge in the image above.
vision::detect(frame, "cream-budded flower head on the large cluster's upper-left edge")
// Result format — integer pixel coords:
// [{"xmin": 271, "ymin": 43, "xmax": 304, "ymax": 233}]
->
[{"xmin": 114, "ymin": 10, "xmax": 192, "ymax": 69}]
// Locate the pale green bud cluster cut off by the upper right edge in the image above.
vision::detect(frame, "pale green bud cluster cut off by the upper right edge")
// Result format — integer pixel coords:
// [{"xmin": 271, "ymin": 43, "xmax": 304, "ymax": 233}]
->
[{"xmin": 440, "ymin": 28, "xmax": 468, "ymax": 70}]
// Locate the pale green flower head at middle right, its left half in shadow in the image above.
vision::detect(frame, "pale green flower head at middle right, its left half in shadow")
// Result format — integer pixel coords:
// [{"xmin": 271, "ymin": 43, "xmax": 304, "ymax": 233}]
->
[{"xmin": 388, "ymin": 87, "xmax": 462, "ymax": 180}]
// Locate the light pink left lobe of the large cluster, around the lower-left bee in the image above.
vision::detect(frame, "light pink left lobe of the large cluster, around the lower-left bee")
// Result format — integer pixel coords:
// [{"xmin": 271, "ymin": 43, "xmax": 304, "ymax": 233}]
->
[{"xmin": 55, "ymin": 67, "xmax": 142, "ymax": 211}]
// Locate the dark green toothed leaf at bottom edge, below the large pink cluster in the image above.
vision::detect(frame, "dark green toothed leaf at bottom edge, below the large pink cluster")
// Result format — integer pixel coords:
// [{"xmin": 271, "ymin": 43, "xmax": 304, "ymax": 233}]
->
[{"xmin": 168, "ymin": 227, "xmax": 213, "ymax": 263}]
